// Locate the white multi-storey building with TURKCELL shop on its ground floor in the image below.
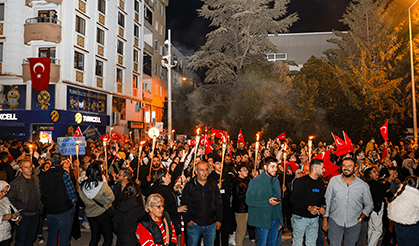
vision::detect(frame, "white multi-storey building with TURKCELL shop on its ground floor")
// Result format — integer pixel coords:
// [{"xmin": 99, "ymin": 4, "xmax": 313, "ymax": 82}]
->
[{"xmin": 0, "ymin": 0, "xmax": 168, "ymax": 140}]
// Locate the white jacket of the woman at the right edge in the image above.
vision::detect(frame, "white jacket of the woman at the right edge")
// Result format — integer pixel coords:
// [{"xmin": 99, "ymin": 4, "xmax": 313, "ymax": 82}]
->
[{"xmin": 387, "ymin": 185, "xmax": 419, "ymax": 225}]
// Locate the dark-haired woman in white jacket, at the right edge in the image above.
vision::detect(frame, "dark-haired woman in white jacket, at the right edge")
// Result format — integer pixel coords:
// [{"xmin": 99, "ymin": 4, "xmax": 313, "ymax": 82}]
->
[{"xmin": 387, "ymin": 176, "xmax": 419, "ymax": 246}]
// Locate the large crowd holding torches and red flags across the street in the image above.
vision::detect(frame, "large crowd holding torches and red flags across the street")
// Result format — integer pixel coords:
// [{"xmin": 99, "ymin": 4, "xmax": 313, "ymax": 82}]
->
[{"xmin": 0, "ymin": 137, "xmax": 419, "ymax": 246}]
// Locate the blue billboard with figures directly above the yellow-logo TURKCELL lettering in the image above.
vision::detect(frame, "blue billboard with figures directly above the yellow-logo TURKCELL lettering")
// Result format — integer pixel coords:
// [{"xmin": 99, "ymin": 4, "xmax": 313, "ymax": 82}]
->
[{"xmin": 67, "ymin": 85, "xmax": 107, "ymax": 115}]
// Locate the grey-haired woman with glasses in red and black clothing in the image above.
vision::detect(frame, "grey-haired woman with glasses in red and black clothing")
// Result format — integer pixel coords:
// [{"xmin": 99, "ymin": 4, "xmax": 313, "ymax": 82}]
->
[{"xmin": 135, "ymin": 194, "xmax": 177, "ymax": 246}]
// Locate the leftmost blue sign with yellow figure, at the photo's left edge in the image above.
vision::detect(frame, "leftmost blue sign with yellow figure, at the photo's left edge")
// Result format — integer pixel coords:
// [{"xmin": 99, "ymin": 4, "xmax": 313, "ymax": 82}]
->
[{"xmin": 0, "ymin": 85, "xmax": 26, "ymax": 110}]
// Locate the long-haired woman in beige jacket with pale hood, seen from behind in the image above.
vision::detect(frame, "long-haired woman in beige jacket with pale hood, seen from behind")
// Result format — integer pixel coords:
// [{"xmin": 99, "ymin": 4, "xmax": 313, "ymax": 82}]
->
[{"xmin": 79, "ymin": 161, "xmax": 115, "ymax": 246}]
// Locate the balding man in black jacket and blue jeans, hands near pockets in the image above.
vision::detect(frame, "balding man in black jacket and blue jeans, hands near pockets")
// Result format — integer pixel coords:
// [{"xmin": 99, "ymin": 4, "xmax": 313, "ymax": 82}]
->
[{"xmin": 182, "ymin": 162, "xmax": 223, "ymax": 246}]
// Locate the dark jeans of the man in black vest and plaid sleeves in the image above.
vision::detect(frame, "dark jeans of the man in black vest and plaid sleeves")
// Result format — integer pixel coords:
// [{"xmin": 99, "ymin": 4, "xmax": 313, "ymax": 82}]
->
[{"xmin": 47, "ymin": 207, "xmax": 74, "ymax": 246}]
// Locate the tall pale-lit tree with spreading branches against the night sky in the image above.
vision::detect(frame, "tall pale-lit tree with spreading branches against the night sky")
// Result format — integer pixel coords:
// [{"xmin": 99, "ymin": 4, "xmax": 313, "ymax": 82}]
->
[{"xmin": 190, "ymin": 0, "xmax": 298, "ymax": 84}]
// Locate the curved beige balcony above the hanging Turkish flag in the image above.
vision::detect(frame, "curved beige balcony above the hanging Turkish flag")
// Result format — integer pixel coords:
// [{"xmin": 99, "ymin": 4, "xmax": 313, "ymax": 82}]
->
[{"xmin": 24, "ymin": 17, "xmax": 61, "ymax": 44}]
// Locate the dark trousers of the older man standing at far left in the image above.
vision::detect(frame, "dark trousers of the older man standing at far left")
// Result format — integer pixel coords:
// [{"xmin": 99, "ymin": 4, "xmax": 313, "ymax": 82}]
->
[{"xmin": 15, "ymin": 213, "xmax": 39, "ymax": 246}]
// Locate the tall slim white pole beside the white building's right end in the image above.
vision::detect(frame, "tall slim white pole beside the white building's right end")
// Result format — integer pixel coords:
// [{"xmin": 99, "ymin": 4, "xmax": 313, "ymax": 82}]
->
[{"xmin": 161, "ymin": 29, "xmax": 177, "ymax": 141}]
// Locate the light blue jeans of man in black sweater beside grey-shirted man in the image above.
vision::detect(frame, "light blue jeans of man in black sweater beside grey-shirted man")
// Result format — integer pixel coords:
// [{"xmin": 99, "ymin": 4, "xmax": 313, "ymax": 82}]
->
[{"xmin": 292, "ymin": 214, "xmax": 319, "ymax": 246}]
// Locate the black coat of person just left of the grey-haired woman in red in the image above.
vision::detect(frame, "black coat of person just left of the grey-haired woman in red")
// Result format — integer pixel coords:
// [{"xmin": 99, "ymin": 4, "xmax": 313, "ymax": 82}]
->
[{"xmin": 113, "ymin": 197, "xmax": 145, "ymax": 246}]
